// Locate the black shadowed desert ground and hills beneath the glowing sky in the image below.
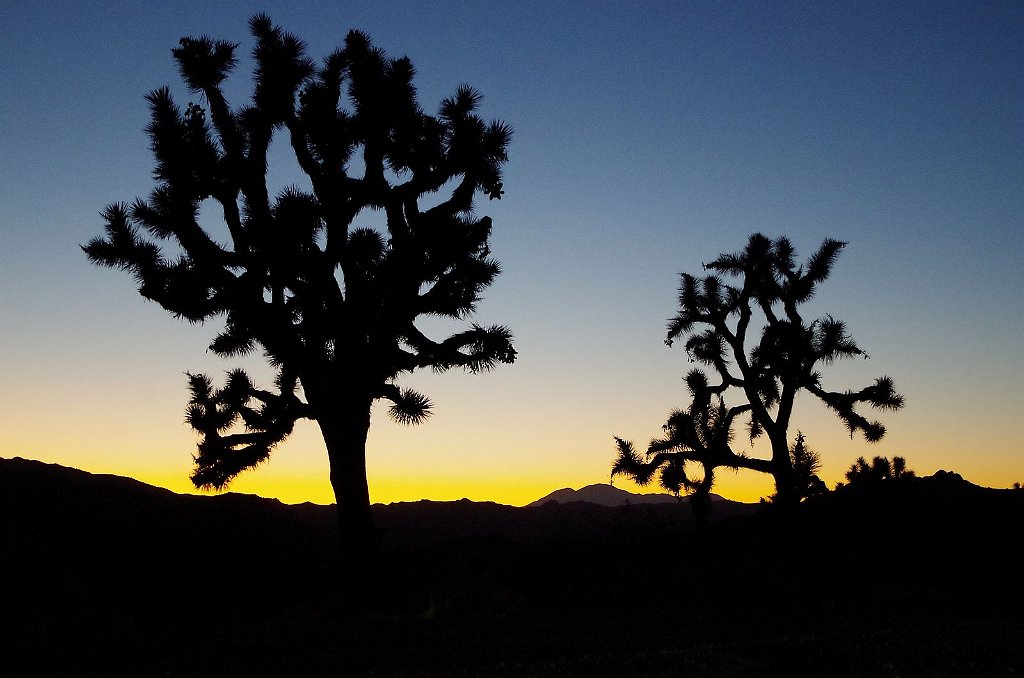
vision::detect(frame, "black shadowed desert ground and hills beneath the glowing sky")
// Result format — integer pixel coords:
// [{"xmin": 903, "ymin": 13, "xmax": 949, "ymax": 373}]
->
[{"xmin": 0, "ymin": 460, "xmax": 1024, "ymax": 677}]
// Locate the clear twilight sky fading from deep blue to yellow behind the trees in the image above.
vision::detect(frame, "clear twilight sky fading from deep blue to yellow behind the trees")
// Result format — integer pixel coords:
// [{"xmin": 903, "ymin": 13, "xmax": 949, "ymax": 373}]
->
[{"xmin": 0, "ymin": 0, "xmax": 1024, "ymax": 504}]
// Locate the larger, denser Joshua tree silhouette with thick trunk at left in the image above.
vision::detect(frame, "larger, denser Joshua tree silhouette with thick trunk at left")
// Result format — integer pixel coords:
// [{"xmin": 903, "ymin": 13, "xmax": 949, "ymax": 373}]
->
[{"xmin": 83, "ymin": 14, "xmax": 516, "ymax": 558}]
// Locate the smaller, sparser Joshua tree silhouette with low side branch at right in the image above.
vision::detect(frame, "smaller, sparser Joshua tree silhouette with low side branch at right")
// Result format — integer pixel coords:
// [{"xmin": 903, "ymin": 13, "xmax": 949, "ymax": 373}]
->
[{"xmin": 612, "ymin": 234, "xmax": 903, "ymax": 505}]
